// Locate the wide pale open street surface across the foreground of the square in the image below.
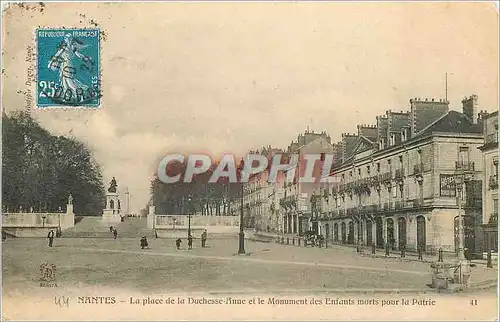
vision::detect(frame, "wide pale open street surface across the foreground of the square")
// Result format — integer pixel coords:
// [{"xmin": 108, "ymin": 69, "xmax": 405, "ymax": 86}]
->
[{"xmin": 3, "ymin": 238, "xmax": 492, "ymax": 292}]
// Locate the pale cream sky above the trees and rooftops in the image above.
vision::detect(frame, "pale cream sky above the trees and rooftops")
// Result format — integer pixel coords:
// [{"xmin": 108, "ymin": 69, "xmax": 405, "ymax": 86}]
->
[{"xmin": 2, "ymin": 2, "xmax": 499, "ymax": 212}]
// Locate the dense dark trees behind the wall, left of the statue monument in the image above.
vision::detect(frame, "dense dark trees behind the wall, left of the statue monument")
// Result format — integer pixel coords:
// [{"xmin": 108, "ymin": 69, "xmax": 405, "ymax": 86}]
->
[{"xmin": 2, "ymin": 112, "xmax": 105, "ymax": 215}]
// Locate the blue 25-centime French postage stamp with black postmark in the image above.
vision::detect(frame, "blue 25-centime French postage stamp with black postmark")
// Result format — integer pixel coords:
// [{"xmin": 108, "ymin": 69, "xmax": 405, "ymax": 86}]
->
[{"xmin": 36, "ymin": 29, "xmax": 101, "ymax": 108}]
